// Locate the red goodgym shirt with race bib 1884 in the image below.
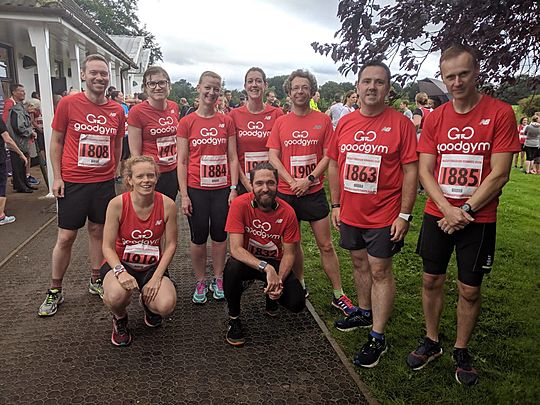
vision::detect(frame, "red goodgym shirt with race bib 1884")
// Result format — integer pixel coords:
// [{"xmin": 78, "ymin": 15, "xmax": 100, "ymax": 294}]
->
[{"xmin": 177, "ymin": 113, "xmax": 235, "ymax": 190}]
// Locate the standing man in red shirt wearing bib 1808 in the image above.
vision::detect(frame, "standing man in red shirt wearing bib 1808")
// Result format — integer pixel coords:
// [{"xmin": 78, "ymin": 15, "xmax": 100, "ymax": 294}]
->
[{"xmin": 38, "ymin": 55, "xmax": 125, "ymax": 316}]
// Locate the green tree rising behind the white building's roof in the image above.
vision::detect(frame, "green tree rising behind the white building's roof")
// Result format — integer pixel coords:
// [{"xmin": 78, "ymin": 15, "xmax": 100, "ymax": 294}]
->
[{"xmin": 75, "ymin": 0, "xmax": 163, "ymax": 64}]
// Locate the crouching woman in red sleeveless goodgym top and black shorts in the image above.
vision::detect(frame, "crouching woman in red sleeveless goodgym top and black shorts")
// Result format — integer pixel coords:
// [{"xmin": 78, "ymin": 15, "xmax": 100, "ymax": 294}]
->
[{"xmin": 101, "ymin": 156, "xmax": 177, "ymax": 346}]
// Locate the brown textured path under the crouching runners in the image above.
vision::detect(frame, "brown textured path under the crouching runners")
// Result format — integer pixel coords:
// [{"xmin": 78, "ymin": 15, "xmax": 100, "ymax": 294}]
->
[{"xmin": 0, "ymin": 207, "xmax": 367, "ymax": 404}]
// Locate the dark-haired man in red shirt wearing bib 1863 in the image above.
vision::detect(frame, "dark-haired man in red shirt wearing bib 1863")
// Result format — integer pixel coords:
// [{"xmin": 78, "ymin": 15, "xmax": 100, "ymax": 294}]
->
[{"xmin": 327, "ymin": 62, "xmax": 418, "ymax": 367}]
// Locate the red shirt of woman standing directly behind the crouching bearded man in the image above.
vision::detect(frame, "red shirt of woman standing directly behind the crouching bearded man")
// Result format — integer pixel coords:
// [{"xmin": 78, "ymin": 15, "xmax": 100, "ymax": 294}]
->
[{"xmin": 229, "ymin": 105, "xmax": 283, "ymax": 179}]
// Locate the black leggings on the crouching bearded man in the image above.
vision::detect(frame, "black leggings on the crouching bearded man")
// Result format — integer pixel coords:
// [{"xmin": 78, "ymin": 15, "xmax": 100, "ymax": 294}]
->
[{"xmin": 223, "ymin": 257, "xmax": 306, "ymax": 317}]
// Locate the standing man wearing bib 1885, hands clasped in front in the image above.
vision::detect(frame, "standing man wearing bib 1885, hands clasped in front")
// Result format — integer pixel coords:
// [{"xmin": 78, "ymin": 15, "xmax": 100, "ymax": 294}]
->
[{"xmin": 407, "ymin": 45, "xmax": 520, "ymax": 385}]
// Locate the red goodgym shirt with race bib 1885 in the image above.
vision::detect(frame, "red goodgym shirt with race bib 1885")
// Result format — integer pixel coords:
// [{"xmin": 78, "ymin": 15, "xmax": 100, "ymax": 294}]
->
[{"xmin": 418, "ymin": 95, "xmax": 521, "ymax": 223}]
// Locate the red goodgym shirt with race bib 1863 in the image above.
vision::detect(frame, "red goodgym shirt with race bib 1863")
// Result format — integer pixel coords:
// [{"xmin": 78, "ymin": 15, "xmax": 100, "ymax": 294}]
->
[{"xmin": 327, "ymin": 108, "xmax": 418, "ymax": 228}]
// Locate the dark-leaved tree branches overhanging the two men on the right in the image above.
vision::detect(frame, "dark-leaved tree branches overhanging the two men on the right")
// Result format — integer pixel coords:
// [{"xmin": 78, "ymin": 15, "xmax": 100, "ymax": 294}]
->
[{"xmin": 311, "ymin": 0, "xmax": 540, "ymax": 84}]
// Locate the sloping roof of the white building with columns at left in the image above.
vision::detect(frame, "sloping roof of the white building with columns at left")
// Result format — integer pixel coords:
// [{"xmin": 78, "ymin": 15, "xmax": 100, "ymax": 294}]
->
[{"xmin": 0, "ymin": 0, "xmax": 138, "ymax": 68}]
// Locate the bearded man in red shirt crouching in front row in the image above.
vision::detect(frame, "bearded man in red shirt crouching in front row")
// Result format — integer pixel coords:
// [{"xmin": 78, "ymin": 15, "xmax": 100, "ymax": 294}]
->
[{"xmin": 223, "ymin": 162, "xmax": 305, "ymax": 346}]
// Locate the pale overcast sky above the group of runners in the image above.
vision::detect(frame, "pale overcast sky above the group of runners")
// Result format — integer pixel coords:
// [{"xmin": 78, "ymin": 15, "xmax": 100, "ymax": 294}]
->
[{"xmin": 139, "ymin": 0, "xmax": 436, "ymax": 89}]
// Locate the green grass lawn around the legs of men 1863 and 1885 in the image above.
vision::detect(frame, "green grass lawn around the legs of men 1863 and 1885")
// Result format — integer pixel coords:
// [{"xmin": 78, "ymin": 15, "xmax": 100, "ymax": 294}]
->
[{"xmin": 302, "ymin": 169, "xmax": 540, "ymax": 404}]
